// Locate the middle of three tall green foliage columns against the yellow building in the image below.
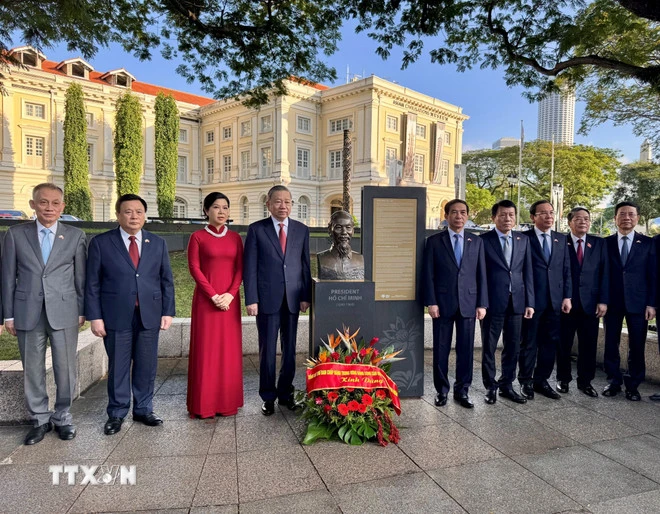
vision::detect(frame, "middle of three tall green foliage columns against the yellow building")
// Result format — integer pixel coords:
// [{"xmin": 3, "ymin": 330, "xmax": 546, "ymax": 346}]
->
[{"xmin": 115, "ymin": 93, "xmax": 142, "ymax": 196}]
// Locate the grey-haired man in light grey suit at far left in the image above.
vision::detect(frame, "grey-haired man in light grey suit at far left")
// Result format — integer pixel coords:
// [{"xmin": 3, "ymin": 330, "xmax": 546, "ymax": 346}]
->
[{"xmin": 2, "ymin": 183, "xmax": 87, "ymax": 445}]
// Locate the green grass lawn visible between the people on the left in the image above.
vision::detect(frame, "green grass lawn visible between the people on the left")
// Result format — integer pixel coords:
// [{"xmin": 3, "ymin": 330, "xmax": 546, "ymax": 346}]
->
[{"xmin": 0, "ymin": 252, "xmax": 317, "ymax": 360}]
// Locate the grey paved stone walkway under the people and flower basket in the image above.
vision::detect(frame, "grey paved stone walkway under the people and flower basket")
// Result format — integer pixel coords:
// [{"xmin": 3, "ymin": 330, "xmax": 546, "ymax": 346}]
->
[{"xmin": 0, "ymin": 352, "xmax": 660, "ymax": 514}]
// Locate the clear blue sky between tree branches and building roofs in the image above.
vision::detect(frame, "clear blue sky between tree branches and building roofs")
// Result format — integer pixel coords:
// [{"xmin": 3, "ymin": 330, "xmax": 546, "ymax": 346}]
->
[{"xmin": 38, "ymin": 28, "xmax": 642, "ymax": 163}]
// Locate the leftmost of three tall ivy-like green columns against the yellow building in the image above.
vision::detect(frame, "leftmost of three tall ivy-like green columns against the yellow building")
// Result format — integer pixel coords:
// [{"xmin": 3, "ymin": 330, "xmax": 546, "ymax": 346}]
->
[{"xmin": 64, "ymin": 83, "xmax": 92, "ymax": 221}]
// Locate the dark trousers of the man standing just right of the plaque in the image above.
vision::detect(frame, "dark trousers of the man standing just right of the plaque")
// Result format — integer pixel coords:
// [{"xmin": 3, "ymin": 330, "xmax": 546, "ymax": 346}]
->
[{"xmin": 433, "ymin": 313, "xmax": 475, "ymax": 395}]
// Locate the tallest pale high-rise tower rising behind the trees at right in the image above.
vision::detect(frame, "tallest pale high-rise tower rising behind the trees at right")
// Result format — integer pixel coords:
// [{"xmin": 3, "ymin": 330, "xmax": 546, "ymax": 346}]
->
[{"xmin": 537, "ymin": 91, "xmax": 575, "ymax": 146}]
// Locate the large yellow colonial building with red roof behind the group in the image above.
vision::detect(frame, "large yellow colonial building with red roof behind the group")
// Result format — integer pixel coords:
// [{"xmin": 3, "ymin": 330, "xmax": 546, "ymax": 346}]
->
[{"xmin": 0, "ymin": 47, "xmax": 467, "ymax": 228}]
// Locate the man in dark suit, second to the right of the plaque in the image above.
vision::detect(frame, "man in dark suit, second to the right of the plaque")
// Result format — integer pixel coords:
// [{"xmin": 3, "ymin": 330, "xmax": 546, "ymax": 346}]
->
[{"xmin": 481, "ymin": 200, "xmax": 534, "ymax": 405}]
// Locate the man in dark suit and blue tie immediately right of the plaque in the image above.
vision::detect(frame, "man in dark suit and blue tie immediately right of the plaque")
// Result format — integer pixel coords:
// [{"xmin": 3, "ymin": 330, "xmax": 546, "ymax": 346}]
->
[{"xmin": 423, "ymin": 199, "xmax": 488, "ymax": 409}]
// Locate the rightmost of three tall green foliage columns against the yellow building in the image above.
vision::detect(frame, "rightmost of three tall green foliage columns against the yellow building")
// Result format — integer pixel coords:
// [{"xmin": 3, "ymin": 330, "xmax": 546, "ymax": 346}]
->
[{"xmin": 154, "ymin": 92, "xmax": 179, "ymax": 218}]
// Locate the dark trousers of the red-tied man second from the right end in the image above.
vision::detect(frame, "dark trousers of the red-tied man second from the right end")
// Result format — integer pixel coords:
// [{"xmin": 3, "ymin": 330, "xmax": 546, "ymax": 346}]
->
[{"xmin": 557, "ymin": 306, "xmax": 600, "ymax": 386}]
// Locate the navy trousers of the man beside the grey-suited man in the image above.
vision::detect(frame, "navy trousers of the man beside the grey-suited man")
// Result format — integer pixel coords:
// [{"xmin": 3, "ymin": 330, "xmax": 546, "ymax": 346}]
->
[{"xmin": 103, "ymin": 307, "xmax": 160, "ymax": 418}]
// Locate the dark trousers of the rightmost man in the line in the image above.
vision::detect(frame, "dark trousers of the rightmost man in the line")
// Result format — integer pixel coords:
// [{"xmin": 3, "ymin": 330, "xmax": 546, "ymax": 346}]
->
[{"xmin": 604, "ymin": 311, "xmax": 649, "ymax": 390}]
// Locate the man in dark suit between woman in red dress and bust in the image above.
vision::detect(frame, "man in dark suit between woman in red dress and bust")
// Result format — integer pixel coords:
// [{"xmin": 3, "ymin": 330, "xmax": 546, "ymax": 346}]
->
[{"xmin": 243, "ymin": 186, "xmax": 312, "ymax": 416}]
